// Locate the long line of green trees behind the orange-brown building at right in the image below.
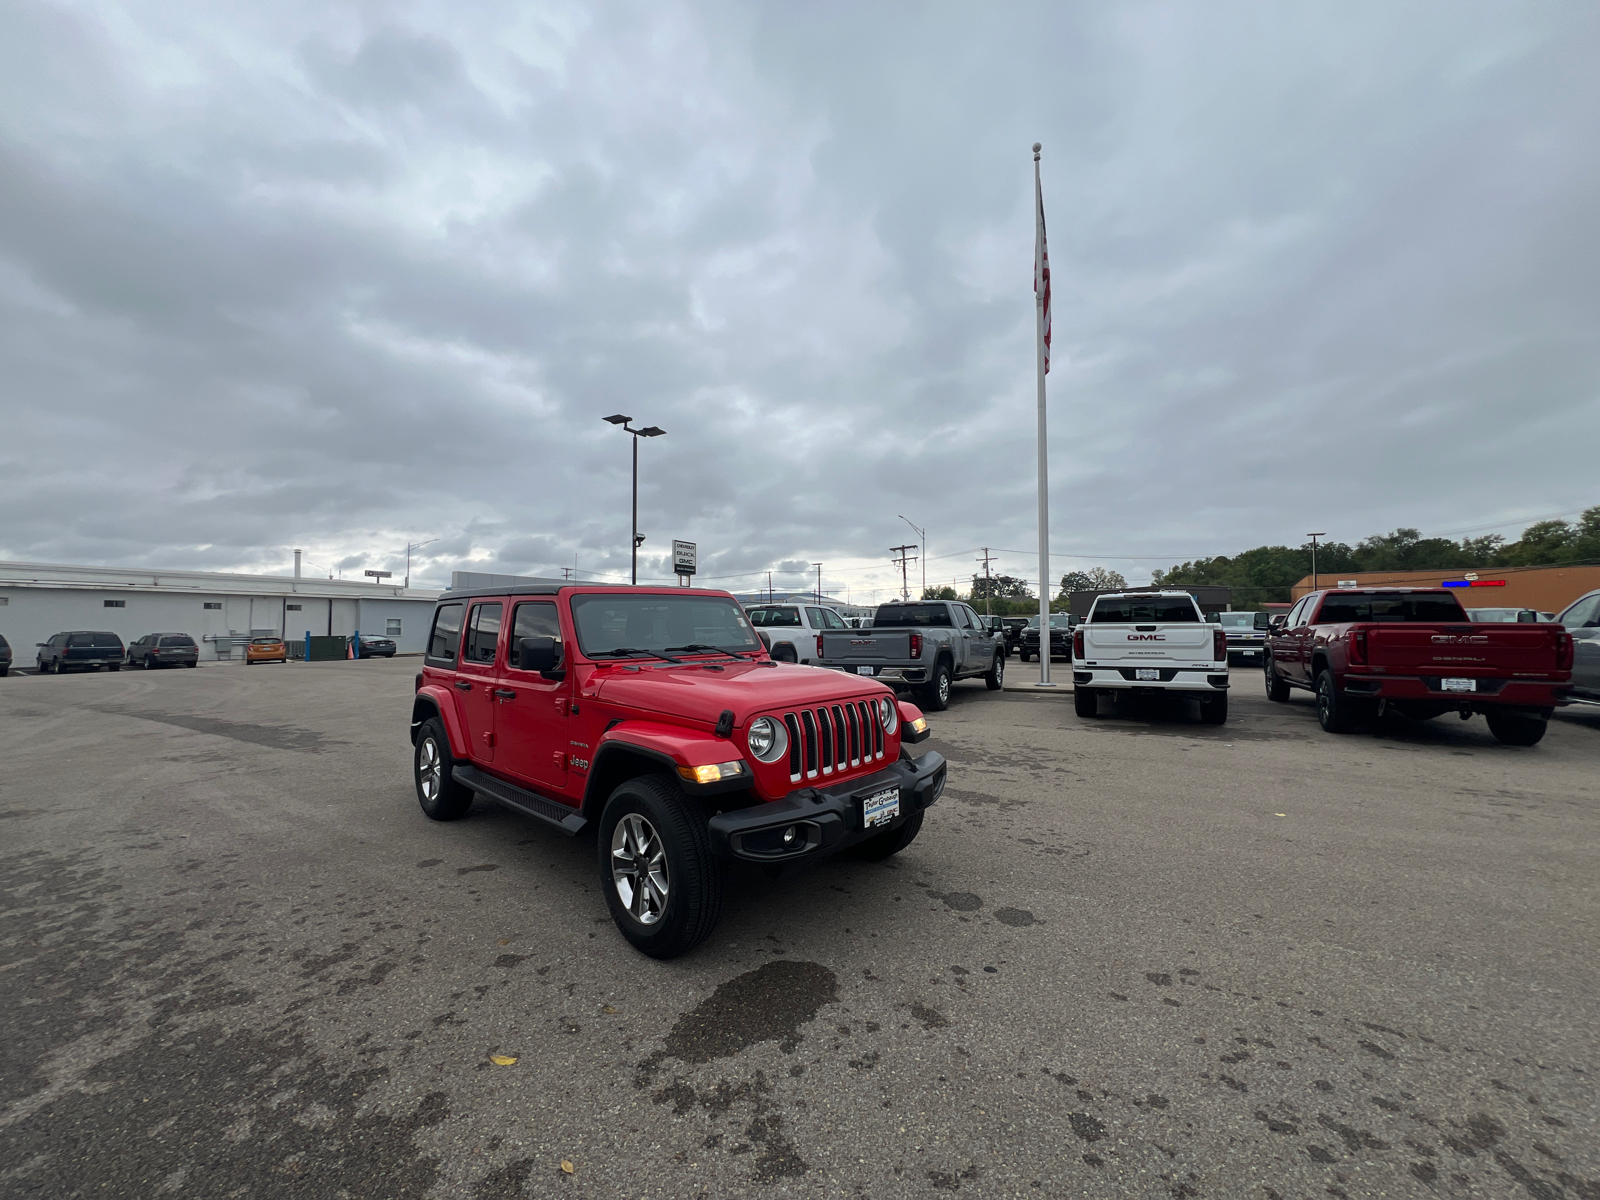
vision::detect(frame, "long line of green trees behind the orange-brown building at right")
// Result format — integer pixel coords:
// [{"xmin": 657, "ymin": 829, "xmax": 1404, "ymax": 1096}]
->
[{"xmin": 1150, "ymin": 506, "xmax": 1600, "ymax": 608}]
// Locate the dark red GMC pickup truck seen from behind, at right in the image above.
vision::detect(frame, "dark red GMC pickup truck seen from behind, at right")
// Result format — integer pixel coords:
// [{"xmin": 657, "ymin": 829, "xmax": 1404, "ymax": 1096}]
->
[{"xmin": 1264, "ymin": 587, "xmax": 1573, "ymax": 746}]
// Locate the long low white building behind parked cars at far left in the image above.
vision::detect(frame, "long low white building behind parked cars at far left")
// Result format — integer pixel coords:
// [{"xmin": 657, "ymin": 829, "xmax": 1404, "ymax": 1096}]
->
[{"xmin": 0, "ymin": 562, "xmax": 438, "ymax": 667}]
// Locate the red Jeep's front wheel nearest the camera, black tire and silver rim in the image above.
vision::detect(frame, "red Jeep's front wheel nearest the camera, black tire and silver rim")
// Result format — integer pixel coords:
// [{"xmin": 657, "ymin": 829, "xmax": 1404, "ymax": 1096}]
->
[{"xmin": 598, "ymin": 774, "xmax": 726, "ymax": 958}]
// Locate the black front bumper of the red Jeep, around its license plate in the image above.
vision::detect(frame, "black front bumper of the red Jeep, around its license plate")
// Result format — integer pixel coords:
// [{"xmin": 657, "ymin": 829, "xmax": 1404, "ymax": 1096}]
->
[{"xmin": 710, "ymin": 750, "xmax": 946, "ymax": 866}]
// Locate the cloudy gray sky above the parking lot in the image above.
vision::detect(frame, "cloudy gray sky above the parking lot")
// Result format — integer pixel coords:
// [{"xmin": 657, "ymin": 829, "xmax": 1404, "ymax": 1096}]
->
[{"xmin": 0, "ymin": 0, "xmax": 1600, "ymax": 597}]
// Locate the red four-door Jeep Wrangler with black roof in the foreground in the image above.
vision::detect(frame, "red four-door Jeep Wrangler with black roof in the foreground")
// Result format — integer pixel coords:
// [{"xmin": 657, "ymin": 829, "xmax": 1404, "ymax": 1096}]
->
[{"xmin": 411, "ymin": 584, "xmax": 946, "ymax": 958}]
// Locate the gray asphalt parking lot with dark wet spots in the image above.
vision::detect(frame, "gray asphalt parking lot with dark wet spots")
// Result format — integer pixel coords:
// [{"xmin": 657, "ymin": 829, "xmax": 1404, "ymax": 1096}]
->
[{"xmin": 0, "ymin": 659, "xmax": 1600, "ymax": 1200}]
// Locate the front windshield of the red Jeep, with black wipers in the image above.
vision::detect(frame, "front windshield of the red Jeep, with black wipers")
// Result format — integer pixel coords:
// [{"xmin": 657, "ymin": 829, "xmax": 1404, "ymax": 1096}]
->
[{"xmin": 573, "ymin": 594, "xmax": 762, "ymax": 661}]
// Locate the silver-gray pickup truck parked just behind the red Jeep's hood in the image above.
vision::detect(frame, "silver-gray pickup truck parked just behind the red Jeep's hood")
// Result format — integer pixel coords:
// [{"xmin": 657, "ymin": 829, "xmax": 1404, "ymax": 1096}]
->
[{"xmin": 818, "ymin": 600, "xmax": 1005, "ymax": 712}]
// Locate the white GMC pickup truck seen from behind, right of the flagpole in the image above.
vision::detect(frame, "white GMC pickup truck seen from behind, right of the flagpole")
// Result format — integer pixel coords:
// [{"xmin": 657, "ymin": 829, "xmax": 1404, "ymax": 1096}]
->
[{"xmin": 1072, "ymin": 592, "xmax": 1227, "ymax": 725}]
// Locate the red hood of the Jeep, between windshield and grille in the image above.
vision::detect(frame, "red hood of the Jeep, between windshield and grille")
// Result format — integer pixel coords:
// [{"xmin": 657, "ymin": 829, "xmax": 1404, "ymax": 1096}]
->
[{"xmin": 584, "ymin": 662, "xmax": 894, "ymax": 728}]
